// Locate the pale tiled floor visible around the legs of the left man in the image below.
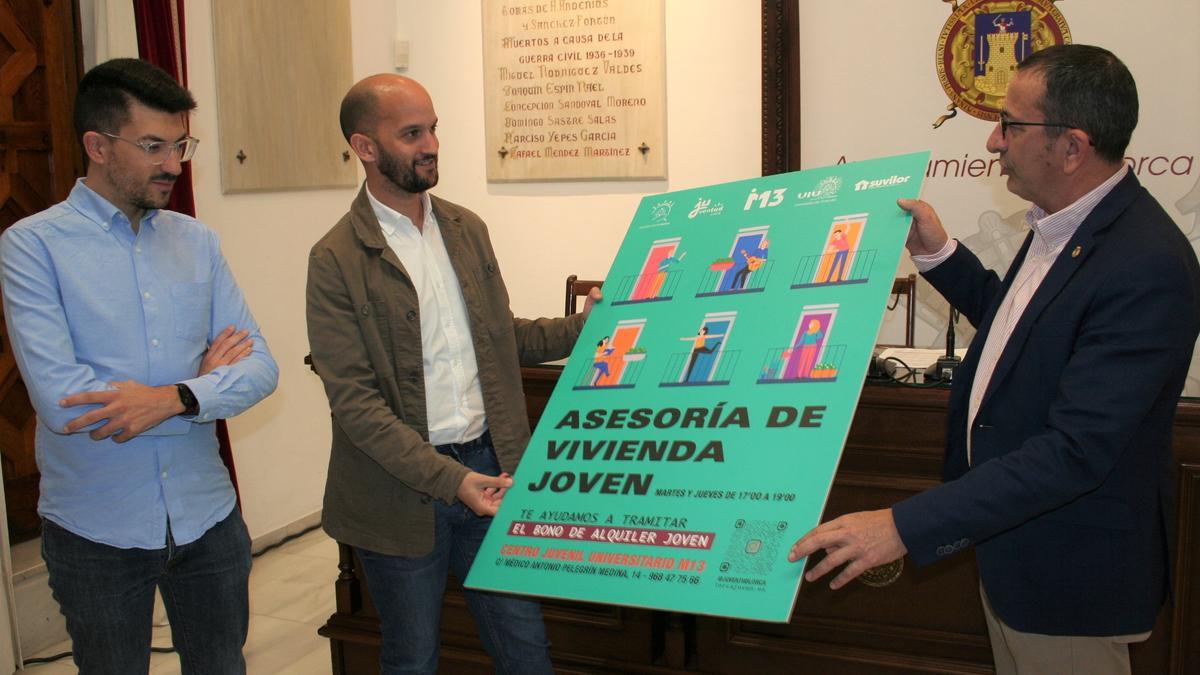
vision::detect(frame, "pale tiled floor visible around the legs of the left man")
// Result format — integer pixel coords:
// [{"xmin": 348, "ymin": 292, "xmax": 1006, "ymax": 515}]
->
[{"xmin": 18, "ymin": 530, "xmax": 337, "ymax": 675}]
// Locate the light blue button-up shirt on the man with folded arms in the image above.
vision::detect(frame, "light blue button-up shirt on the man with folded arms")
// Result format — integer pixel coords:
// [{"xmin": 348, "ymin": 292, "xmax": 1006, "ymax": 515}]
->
[{"xmin": 0, "ymin": 179, "xmax": 278, "ymax": 549}]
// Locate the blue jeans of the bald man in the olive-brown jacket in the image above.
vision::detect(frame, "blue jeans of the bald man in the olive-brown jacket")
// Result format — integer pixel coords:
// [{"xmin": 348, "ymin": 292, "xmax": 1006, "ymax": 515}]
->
[{"xmin": 355, "ymin": 432, "xmax": 554, "ymax": 675}]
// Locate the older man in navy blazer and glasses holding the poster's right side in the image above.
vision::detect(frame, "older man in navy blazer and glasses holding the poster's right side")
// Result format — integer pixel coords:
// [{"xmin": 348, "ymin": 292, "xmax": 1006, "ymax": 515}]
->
[{"xmin": 790, "ymin": 44, "xmax": 1200, "ymax": 673}]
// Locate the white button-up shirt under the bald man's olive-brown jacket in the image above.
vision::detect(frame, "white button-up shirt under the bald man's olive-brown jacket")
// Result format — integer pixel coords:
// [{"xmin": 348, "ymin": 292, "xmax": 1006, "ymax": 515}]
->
[{"xmin": 367, "ymin": 189, "xmax": 487, "ymax": 446}]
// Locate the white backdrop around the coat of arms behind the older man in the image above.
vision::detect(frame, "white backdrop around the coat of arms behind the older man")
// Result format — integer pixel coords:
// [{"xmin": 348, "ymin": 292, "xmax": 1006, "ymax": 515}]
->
[{"xmin": 799, "ymin": 0, "xmax": 1200, "ymax": 389}]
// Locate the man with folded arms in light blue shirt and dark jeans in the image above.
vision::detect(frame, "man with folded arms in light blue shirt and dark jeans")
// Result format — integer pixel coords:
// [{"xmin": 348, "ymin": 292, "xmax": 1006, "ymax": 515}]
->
[{"xmin": 0, "ymin": 59, "xmax": 278, "ymax": 675}]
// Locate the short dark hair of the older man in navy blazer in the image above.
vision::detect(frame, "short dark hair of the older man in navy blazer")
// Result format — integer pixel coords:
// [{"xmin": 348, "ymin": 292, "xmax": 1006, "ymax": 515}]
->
[{"xmin": 1018, "ymin": 44, "xmax": 1138, "ymax": 162}]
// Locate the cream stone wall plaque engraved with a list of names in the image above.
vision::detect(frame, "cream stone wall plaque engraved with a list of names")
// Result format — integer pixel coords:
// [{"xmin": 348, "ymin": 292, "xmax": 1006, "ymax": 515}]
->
[{"xmin": 484, "ymin": 0, "xmax": 666, "ymax": 181}]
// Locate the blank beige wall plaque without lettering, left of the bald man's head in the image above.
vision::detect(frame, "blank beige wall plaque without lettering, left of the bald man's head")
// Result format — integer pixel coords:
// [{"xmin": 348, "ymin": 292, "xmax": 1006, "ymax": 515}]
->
[{"xmin": 212, "ymin": 0, "xmax": 358, "ymax": 192}]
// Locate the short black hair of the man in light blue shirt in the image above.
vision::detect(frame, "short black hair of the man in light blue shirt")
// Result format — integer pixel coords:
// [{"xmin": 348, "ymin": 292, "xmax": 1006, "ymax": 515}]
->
[{"xmin": 74, "ymin": 59, "xmax": 196, "ymax": 138}]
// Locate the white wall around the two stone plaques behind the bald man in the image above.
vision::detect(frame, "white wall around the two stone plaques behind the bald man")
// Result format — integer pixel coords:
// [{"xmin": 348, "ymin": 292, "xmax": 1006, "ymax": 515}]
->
[{"xmin": 186, "ymin": 0, "xmax": 761, "ymax": 537}]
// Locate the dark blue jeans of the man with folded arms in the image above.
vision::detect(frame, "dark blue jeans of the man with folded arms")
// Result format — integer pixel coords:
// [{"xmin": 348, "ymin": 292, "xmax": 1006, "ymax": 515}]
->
[{"xmin": 42, "ymin": 508, "xmax": 250, "ymax": 675}]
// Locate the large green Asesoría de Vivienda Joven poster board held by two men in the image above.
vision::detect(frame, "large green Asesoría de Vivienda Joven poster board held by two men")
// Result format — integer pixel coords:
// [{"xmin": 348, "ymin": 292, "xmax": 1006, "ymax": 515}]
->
[{"xmin": 466, "ymin": 153, "xmax": 929, "ymax": 622}]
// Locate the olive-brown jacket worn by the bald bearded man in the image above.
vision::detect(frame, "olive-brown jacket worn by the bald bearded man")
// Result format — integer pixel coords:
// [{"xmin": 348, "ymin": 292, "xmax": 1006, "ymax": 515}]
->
[{"xmin": 307, "ymin": 189, "xmax": 583, "ymax": 556}]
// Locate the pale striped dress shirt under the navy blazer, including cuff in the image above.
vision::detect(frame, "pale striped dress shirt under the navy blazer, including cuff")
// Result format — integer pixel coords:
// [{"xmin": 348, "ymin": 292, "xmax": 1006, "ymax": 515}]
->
[{"xmin": 912, "ymin": 163, "xmax": 1129, "ymax": 464}]
